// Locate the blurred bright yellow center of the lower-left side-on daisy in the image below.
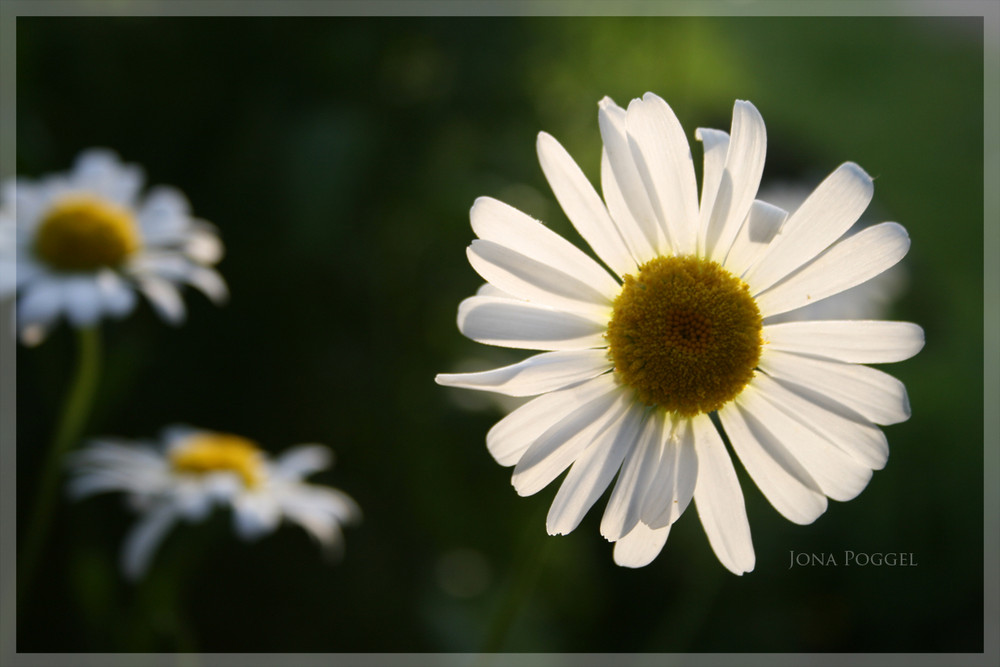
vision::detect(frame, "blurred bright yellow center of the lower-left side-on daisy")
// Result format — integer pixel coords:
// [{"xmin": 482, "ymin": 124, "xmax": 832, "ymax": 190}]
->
[{"xmin": 170, "ymin": 433, "xmax": 264, "ymax": 488}]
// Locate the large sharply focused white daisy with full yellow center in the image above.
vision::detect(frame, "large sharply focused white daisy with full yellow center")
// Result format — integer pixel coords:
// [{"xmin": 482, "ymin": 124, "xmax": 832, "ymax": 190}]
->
[{"xmin": 436, "ymin": 93, "xmax": 924, "ymax": 574}]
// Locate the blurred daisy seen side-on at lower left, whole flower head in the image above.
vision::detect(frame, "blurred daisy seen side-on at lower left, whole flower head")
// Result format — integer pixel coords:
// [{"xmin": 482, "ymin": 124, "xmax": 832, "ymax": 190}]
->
[{"xmin": 69, "ymin": 427, "xmax": 361, "ymax": 579}]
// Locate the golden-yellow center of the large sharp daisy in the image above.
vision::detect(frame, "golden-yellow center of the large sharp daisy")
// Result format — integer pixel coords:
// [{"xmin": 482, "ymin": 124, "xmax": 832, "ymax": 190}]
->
[{"xmin": 605, "ymin": 256, "xmax": 762, "ymax": 417}]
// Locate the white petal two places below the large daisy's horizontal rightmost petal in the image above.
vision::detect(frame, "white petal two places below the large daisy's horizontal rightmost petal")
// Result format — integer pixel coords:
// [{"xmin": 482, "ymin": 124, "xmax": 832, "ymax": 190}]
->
[{"xmin": 753, "ymin": 373, "xmax": 889, "ymax": 470}]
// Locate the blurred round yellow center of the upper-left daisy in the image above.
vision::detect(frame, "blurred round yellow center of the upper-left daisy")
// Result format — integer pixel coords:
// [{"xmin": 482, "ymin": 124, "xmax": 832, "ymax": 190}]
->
[{"xmin": 35, "ymin": 195, "xmax": 139, "ymax": 271}]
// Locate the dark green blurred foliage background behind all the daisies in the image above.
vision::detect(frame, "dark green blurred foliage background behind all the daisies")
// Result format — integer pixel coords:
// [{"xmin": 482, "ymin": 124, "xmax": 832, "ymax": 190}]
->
[{"xmin": 17, "ymin": 17, "xmax": 983, "ymax": 652}]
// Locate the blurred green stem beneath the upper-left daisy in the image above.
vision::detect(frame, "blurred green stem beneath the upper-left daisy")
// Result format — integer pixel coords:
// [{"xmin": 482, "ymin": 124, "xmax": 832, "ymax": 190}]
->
[{"xmin": 17, "ymin": 326, "xmax": 101, "ymax": 607}]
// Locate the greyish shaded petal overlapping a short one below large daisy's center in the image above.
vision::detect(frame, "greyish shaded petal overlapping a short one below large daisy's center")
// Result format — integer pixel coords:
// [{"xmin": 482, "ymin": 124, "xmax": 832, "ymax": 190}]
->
[{"xmin": 639, "ymin": 419, "xmax": 698, "ymax": 528}]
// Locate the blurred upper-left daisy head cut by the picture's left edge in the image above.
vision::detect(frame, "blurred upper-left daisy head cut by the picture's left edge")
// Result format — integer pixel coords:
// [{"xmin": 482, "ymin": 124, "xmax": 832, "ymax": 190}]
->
[{"xmin": 0, "ymin": 149, "xmax": 227, "ymax": 344}]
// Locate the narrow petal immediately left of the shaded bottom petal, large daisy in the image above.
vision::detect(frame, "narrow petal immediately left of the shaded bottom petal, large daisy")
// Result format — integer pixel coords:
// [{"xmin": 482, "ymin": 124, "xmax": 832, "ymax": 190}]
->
[{"xmin": 601, "ymin": 406, "xmax": 665, "ymax": 542}]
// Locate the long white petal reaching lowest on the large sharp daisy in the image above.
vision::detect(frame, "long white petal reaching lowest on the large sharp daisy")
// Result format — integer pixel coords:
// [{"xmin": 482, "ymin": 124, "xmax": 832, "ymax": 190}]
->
[{"xmin": 691, "ymin": 415, "xmax": 756, "ymax": 575}]
